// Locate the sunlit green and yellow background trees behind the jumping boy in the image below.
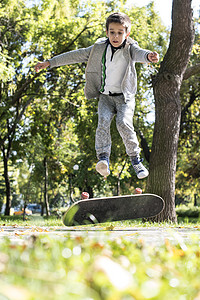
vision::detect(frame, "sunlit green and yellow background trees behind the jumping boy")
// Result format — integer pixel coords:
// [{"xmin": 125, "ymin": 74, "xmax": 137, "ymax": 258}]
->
[{"xmin": 0, "ymin": 0, "xmax": 200, "ymax": 220}]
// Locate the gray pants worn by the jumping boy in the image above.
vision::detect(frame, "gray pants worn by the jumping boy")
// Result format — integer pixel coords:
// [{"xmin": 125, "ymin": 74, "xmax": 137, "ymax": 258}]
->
[{"xmin": 95, "ymin": 94, "xmax": 140, "ymax": 158}]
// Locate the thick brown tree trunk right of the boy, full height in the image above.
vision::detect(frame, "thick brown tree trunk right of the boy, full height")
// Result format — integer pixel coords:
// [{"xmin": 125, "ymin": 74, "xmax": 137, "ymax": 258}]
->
[{"xmin": 147, "ymin": 0, "xmax": 194, "ymax": 222}]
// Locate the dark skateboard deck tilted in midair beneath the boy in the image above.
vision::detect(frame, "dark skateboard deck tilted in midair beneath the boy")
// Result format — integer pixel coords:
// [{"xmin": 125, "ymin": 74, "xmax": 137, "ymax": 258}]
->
[{"xmin": 63, "ymin": 194, "xmax": 164, "ymax": 226}]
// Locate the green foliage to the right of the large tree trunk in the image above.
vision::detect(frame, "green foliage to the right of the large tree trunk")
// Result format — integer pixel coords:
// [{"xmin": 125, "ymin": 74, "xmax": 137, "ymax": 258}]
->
[{"xmin": 176, "ymin": 27, "xmax": 200, "ymax": 196}]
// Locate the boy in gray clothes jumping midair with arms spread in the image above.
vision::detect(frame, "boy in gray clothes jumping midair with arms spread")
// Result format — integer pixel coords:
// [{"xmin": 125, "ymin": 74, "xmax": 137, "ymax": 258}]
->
[{"xmin": 35, "ymin": 12, "xmax": 159, "ymax": 179}]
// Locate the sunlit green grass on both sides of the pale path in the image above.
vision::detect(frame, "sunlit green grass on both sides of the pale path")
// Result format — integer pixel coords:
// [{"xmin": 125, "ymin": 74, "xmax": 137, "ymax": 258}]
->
[{"xmin": 0, "ymin": 216, "xmax": 200, "ymax": 300}]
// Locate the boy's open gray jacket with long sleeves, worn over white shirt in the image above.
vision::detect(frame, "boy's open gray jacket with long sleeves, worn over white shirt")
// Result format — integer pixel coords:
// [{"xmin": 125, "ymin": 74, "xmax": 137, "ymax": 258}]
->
[{"xmin": 49, "ymin": 37, "xmax": 151, "ymax": 102}]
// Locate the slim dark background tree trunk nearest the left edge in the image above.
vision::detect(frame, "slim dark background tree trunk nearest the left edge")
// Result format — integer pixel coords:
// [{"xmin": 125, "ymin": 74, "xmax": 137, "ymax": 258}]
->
[{"xmin": 2, "ymin": 147, "xmax": 11, "ymax": 216}]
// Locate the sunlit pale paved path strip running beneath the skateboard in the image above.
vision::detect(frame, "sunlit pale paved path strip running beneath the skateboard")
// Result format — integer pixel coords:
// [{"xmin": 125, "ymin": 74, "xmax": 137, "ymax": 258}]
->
[{"xmin": 0, "ymin": 225, "xmax": 200, "ymax": 247}]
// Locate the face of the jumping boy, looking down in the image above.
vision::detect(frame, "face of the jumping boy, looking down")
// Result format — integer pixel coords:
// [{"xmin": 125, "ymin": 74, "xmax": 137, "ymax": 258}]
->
[{"xmin": 106, "ymin": 23, "xmax": 130, "ymax": 47}]
